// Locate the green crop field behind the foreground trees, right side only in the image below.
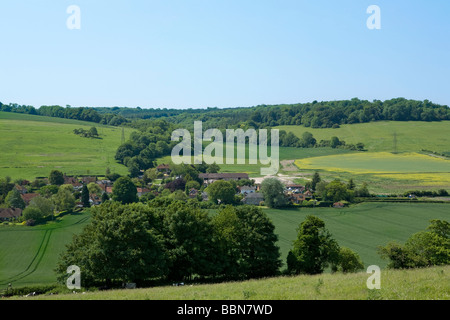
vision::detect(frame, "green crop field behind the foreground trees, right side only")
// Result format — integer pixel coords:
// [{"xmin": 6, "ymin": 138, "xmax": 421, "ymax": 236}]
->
[{"xmin": 265, "ymin": 203, "xmax": 450, "ymax": 268}]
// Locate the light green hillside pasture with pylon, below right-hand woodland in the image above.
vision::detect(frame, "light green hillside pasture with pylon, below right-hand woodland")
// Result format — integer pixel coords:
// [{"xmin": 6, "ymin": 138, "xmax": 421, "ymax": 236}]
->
[{"xmin": 276, "ymin": 121, "xmax": 450, "ymax": 155}]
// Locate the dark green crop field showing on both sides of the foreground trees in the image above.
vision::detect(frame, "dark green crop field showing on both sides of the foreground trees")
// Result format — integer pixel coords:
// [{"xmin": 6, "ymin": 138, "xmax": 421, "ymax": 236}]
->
[{"xmin": 0, "ymin": 203, "xmax": 450, "ymax": 290}]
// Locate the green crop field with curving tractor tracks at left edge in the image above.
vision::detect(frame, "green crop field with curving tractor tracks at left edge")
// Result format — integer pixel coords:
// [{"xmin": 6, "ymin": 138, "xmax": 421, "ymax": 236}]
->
[{"xmin": 0, "ymin": 213, "xmax": 90, "ymax": 290}]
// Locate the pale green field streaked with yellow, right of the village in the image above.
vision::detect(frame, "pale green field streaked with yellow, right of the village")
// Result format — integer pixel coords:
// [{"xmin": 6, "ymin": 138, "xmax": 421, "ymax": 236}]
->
[{"xmin": 295, "ymin": 152, "xmax": 450, "ymax": 193}]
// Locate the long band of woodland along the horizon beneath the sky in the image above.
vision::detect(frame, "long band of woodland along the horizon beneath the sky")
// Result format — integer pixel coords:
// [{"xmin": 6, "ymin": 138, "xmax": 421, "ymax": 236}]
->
[{"xmin": 0, "ymin": 98, "xmax": 450, "ymax": 129}]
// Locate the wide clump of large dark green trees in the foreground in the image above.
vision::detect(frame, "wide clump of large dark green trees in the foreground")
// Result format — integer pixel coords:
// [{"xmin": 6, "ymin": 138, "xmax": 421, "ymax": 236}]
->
[{"xmin": 57, "ymin": 199, "xmax": 281, "ymax": 286}]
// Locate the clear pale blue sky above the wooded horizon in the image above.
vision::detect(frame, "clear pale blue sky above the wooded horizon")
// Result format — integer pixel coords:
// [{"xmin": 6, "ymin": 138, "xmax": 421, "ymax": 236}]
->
[{"xmin": 0, "ymin": 0, "xmax": 450, "ymax": 108}]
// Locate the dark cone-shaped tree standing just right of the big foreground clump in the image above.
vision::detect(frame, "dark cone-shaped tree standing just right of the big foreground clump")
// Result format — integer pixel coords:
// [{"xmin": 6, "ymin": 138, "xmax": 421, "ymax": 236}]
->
[{"xmin": 287, "ymin": 215, "xmax": 339, "ymax": 274}]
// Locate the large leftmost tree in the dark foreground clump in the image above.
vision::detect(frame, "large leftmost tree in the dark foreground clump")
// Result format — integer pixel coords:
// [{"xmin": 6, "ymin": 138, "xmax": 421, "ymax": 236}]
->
[{"xmin": 56, "ymin": 202, "xmax": 167, "ymax": 286}]
